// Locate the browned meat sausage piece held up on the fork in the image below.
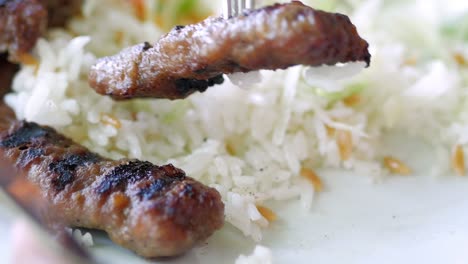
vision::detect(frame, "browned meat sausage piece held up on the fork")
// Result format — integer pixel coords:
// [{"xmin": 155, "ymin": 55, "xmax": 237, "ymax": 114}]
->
[{"xmin": 89, "ymin": 1, "xmax": 370, "ymax": 99}]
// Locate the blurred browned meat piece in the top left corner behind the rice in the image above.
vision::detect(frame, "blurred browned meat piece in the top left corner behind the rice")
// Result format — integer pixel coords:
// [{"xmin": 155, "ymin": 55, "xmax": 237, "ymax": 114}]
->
[{"xmin": 0, "ymin": 0, "xmax": 83, "ymax": 62}]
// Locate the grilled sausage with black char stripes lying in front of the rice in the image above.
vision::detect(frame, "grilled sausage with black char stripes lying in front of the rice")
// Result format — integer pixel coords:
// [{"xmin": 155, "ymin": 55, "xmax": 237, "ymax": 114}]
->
[{"xmin": 0, "ymin": 121, "xmax": 224, "ymax": 257}]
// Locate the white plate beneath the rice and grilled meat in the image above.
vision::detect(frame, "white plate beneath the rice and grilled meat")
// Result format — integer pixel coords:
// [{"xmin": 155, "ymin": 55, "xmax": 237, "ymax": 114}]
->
[{"xmin": 0, "ymin": 135, "xmax": 468, "ymax": 264}]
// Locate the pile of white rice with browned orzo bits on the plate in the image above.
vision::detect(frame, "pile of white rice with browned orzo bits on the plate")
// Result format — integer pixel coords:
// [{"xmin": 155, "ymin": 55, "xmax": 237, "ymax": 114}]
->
[{"xmin": 6, "ymin": 0, "xmax": 468, "ymax": 244}]
